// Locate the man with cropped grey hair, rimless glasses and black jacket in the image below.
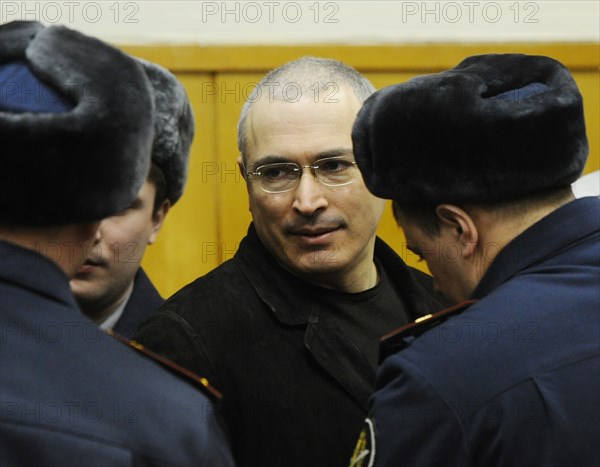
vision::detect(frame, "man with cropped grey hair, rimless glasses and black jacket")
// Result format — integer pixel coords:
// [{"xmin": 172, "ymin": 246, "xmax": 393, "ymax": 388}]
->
[{"xmin": 136, "ymin": 57, "xmax": 446, "ymax": 467}]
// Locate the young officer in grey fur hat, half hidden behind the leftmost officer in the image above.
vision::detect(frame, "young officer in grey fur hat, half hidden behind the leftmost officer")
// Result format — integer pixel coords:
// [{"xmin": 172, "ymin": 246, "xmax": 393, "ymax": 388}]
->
[{"xmin": 71, "ymin": 59, "xmax": 194, "ymax": 338}]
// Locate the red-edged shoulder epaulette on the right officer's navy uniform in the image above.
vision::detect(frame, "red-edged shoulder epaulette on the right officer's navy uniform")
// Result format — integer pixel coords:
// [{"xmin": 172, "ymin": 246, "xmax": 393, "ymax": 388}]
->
[{"xmin": 379, "ymin": 300, "xmax": 477, "ymax": 363}]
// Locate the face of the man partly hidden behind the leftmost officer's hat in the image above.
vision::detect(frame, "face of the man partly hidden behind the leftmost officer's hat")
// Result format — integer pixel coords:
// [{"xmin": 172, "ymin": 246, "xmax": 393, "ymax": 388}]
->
[{"xmin": 71, "ymin": 181, "xmax": 164, "ymax": 318}]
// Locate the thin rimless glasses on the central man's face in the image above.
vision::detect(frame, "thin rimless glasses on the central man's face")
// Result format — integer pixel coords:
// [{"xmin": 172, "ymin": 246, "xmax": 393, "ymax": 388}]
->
[{"xmin": 247, "ymin": 156, "xmax": 359, "ymax": 193}]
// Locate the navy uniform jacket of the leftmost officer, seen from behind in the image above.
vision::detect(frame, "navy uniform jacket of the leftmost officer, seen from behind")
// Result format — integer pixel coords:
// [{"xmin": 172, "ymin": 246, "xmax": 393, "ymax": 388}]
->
[{"xmin": 0, "ymin": 242, "xmax": 233, "ymax": 467}]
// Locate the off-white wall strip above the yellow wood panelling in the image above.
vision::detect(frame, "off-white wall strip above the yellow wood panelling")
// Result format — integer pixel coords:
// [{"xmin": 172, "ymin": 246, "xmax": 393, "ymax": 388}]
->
[{"xmin": 0, "ymin": 0, "xmax": 599, "ymax": 45}]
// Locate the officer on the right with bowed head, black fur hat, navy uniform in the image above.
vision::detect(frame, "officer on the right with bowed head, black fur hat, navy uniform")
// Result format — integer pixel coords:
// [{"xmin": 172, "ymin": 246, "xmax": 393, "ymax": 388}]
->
[{"xmin": 351, "ymin": 54, "xmax": 600, "ymax": 467}]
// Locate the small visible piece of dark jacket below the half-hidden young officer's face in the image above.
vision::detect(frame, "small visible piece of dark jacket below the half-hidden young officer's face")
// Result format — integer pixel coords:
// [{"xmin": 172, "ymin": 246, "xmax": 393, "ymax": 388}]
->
[{"xmin": 113, "ymin": 268, "xmax": 164, "ymax": 339}]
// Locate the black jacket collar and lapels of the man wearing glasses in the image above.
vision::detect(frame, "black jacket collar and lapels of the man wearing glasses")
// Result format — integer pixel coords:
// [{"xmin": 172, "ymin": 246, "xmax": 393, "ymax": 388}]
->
[{"xmin": 234, "ymin": 224, "xmax": 439, "ymax": 412}]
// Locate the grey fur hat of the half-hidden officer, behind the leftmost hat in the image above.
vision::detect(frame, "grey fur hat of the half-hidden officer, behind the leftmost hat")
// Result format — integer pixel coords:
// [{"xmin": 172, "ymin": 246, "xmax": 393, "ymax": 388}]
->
[{"xmin": 138, "ymin": 58, "xmax": 195, "ymax": 205}]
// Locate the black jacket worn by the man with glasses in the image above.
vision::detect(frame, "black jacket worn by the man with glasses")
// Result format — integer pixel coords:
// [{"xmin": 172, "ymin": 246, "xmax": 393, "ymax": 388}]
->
[{"xmin": 136, "ymin": 226, "xmax": 440, "ymax": 467}]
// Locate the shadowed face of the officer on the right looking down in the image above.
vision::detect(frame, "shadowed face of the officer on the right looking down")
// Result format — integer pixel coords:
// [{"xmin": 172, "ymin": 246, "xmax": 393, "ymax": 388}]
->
[{"xmin": 400, "ymin": 218, "xmax": 474, "ymax": 303}]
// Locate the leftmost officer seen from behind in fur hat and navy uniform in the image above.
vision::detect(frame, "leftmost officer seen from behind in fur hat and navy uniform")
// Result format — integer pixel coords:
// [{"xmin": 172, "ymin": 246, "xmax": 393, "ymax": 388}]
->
[{"xmin": 0, "ymin": 22, "xmax": 233, "ymax": 466}]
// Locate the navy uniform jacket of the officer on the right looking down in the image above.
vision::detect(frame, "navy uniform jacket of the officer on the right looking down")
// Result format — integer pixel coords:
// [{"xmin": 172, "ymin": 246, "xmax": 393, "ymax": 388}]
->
[{"xmin": 364, "ymin": 198, "xmax": 600, "ymax": 467}]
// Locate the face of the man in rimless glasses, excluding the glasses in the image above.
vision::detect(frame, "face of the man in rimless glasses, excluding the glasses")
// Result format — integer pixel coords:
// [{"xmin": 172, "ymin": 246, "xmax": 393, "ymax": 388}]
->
[{"xmin": 241, "ymin": 86, "xmax": 385, "ymax": 286}]
